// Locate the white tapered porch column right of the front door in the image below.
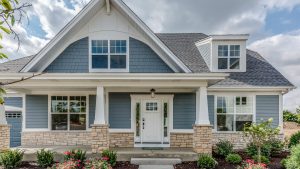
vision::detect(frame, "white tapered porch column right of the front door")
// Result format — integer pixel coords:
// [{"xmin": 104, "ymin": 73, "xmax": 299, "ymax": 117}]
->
[{"xmin": 195, "ymin": 86, "xmax": 210, "ymax": 125}]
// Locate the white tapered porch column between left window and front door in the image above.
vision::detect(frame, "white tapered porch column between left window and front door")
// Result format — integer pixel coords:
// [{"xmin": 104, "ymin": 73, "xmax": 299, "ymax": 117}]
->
[{"xmin": 94, "ymin": 86, "xmax": 106, "ymax": 124}]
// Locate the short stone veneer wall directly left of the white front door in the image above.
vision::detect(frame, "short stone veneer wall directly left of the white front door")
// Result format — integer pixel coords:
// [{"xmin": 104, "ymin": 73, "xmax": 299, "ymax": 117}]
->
[{"xmin": 109, "ymin": 132, "xmax": 134, "ymax": 147}]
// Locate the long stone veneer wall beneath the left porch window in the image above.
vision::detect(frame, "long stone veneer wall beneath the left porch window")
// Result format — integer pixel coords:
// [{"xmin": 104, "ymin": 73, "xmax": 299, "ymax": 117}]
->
[{"xmin": 22, "ymin": 131, "xmax": 92, "ymax": 146}]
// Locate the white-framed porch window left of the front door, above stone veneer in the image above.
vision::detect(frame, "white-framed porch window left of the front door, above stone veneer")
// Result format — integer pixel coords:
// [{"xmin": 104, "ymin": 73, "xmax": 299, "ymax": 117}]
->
[{"xmin": 50, "ymin": 96, "xmax": 87, "ymax": 130}]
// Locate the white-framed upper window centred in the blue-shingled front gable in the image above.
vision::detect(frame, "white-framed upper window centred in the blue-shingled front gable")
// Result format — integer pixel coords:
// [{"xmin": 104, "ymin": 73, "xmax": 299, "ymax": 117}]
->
[{"xmin": 91, "ymin": 40, "xmax": 128, "ymax": 70}]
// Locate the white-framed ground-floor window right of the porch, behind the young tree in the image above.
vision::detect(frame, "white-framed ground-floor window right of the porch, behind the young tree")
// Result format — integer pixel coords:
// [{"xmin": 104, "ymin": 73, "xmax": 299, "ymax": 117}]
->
[{"xmin": 215, "ymin": 96, "xmax": 253, "ymax": 131}]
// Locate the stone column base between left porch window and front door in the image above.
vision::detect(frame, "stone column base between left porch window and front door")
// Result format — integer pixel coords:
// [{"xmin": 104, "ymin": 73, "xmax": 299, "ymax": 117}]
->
[{"xmin": 91, "ymin": 124, "xmax": 109, "ymax": 153}]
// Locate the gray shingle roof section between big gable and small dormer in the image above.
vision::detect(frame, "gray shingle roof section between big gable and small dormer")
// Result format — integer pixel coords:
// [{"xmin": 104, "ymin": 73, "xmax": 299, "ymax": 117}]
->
[{"xmin": 156, "ymin": 33, "xmax": 209, "ymax": 73}]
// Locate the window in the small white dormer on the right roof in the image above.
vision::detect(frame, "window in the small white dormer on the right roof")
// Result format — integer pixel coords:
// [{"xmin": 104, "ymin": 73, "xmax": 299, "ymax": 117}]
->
[{"xmin": 218, "ymin": 45, "xmax": 240, "ymax": 70}]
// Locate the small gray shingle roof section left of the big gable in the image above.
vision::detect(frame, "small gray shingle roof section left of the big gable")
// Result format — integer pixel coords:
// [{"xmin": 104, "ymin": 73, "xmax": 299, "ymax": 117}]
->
[{"xmin": 0, "ymin": 55, "xmax": 35, "ymax": 73}]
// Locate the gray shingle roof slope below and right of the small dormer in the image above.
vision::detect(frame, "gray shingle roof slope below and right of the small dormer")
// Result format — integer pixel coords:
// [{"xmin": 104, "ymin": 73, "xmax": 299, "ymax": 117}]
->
[{"xmin": 211, "ymin": 50, "xmax": 293, "ymax": 87}]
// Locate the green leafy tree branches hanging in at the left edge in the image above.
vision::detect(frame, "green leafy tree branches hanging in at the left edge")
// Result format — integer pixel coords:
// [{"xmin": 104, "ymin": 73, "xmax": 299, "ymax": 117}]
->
[{"xmin": 0, "ymin": 0, "xmax": 31, "ymax": 104}]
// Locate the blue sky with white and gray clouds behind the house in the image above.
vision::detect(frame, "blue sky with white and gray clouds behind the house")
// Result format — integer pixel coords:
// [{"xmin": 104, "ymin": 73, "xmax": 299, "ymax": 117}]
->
[{"xmin": 4, "ymin": 0, "xmax": 300, "ymax": 110}]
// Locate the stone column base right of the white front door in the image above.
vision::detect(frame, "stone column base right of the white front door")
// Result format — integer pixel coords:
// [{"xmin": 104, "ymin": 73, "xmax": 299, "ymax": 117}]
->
[{"xmin": 193, "ymin": 125, "xmax": 212, "ymax": 154}]
